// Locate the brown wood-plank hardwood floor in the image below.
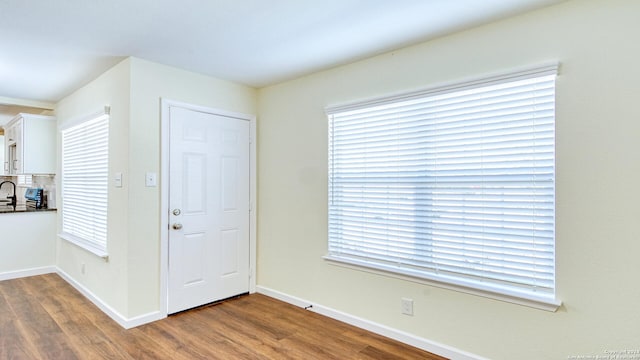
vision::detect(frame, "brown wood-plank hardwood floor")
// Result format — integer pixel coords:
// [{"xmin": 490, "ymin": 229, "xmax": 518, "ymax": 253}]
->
[{"xmin": 0, "ymin": 274, "xmax": 444, "ymax": 360}]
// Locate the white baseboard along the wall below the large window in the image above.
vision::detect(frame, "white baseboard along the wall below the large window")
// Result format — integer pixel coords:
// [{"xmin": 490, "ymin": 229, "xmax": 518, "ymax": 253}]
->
[{"xmin": 256, "ymin": 286, "xmax": 486, "ymax": 360}]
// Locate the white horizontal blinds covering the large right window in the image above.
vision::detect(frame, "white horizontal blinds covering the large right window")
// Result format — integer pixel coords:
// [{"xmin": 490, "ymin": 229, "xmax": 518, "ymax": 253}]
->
[{"xmin": 328, "ymin": 67, "xmax": 556, "ymax": 296}]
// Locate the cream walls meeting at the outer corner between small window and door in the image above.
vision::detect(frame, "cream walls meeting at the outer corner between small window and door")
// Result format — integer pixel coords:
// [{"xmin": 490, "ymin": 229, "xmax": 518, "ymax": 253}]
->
[{"xmin": 56, "ymin": 58, "xmax": 256, "ymax": 319}]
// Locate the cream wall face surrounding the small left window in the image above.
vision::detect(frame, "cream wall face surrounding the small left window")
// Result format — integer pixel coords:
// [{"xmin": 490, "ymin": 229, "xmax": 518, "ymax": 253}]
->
[{"xmin": 55, "ymin": 59, "xmax": 131, "ymax": 316}]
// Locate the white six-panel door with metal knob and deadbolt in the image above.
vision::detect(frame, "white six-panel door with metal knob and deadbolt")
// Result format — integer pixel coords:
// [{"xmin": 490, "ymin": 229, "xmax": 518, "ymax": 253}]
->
[{"xmin": 167, "ymin": 107, "xmax": 250, "ymax": 314}]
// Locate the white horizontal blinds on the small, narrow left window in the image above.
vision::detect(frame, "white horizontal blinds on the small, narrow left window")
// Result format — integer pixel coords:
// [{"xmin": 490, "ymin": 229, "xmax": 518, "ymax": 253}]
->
[{"xmin": 62, "ymin": 114, "xmax": 109, "ymax": 251}]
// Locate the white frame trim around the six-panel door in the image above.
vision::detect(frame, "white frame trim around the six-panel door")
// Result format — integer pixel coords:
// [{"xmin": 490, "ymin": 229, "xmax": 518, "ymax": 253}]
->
[{"xmin": 160, "ymin": 99, "xmax": 257, "ymax": 317}]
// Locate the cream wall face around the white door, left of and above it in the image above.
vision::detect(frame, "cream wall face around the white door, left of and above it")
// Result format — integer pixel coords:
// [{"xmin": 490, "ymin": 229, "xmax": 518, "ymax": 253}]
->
[{"xmin": 128, "ymin": 58, "xmax": 256, "ymax": 316}]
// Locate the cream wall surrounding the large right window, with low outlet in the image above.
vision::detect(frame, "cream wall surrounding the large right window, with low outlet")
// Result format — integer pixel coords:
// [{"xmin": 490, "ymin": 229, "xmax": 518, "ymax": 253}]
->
[{"xmin": 258, "ymin": 0, "xmax": 640, "ymax": 360}]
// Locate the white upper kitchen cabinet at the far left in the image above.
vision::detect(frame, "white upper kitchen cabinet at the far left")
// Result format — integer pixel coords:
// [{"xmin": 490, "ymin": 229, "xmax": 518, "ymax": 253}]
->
[{"xmin": 4, "ymin": 114, "xmax": 56, "ymax": 175}]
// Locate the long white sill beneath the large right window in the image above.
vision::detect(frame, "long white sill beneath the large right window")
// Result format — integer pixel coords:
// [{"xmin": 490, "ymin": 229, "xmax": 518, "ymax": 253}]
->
[{"xmin": 323, "ymin": 255, "xmax": 562, "ymax": 312}]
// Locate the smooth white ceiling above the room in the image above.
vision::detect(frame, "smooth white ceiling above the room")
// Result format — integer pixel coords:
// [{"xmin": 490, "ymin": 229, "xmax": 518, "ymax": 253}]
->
[{"xmin": 0, "ymin": 0, "xmax": 562, "ymax": 102}]
